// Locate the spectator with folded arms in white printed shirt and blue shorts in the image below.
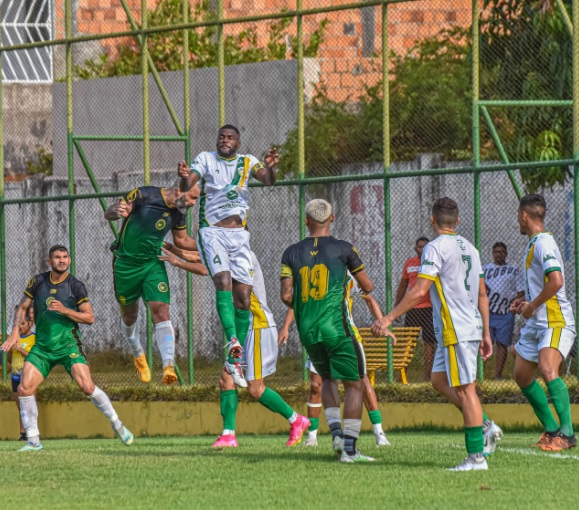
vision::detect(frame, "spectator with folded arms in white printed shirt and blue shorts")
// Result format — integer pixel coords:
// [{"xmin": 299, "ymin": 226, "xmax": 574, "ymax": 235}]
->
[{"xmin": 483, "ymin": 242, "xmax": 524, "ymax": 379}]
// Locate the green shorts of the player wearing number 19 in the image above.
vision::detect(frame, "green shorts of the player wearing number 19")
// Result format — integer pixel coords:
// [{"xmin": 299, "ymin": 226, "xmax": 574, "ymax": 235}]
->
[{"xmin": 304, "ymin": 336, "xmax": 365, "ymax": 381}]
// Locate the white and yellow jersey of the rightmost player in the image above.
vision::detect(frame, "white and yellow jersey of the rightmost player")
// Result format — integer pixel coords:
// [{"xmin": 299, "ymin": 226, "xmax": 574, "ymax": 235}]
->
[{"xmin": 523, "ymin": 232, "xmax": 575, "ymax": 329}]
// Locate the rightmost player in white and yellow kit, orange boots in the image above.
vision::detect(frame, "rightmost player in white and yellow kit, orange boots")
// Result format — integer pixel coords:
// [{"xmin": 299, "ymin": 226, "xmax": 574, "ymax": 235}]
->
[{"xmin": 511, "ymin": 194, "xmax": 577, "ymax": 452}]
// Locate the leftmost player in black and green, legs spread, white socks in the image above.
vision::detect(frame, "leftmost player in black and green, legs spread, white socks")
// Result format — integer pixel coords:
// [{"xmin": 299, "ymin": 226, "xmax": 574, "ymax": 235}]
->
[{"xmin": 2, "ymin": 245, "xmax": 133, "ymax": 451}]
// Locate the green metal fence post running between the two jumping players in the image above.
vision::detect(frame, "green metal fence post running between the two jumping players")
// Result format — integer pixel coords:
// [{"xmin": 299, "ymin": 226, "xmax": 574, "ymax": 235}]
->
[{"xmin": 182, "ymin": 0, "xmax": 195, "ymax": 384}]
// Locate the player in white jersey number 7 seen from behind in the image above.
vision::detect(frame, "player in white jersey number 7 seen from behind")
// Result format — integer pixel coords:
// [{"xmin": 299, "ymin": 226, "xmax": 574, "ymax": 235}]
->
[{"xmin": 372, "ymin": 197, "xmax": 502, "ymax": 471}]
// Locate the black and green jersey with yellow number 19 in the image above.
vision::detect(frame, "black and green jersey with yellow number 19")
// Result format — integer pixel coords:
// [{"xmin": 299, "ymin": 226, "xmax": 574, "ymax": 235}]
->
[{"xmin": 281, "ymin": 236, "xmax": 364, "ymax": 345}]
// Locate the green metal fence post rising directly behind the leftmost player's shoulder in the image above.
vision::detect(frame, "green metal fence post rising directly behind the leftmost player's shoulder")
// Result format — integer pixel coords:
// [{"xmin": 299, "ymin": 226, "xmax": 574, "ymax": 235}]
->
[{"xmin": 64, "ymin": 0, "xmax": 76, "ymax": 274}]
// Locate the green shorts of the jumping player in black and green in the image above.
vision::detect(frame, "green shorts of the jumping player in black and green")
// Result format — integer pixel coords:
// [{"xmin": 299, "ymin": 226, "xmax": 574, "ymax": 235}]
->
[{"xmin": 113, "ymin": 258, "xmax": 171, "ymax": 305}]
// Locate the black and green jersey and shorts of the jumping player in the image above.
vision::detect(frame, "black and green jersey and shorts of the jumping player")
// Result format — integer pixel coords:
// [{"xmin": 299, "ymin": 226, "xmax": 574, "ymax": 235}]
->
[{"xmin": 113, "ymin": 186, "xmax": 187, "ymax": 305}]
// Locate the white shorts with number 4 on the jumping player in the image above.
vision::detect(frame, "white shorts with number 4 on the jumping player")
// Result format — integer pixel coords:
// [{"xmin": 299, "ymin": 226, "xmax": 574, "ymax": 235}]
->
[{"xmin": 197, "ymin": 227, "xmax": 253, "ymax": 285}]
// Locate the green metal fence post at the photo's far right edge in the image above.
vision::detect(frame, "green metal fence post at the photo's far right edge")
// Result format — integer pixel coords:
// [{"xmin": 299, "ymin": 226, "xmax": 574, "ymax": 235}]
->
[{"xmin": 572, "ymin": 1, "xmax": 579, "ymax": 378}]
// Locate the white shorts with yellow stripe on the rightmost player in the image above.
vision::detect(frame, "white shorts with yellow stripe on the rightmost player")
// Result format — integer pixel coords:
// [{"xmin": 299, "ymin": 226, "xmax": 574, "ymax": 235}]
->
[{"xmin": 515, "ymin": 325, "xmax": 575, "ymax": 363}]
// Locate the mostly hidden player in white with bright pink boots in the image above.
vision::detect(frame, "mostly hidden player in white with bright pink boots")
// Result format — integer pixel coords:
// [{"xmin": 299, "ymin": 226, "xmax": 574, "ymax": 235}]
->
[{"xmin": 165, "ymin": 247, "xmax": 310, "ymax": 448}]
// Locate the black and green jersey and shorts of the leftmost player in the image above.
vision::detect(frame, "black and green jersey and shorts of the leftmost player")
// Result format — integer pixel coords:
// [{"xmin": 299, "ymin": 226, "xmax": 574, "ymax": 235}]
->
[{"xmin": 24, "ymin": 271, "xmax": 88, "ymax": 379}]
